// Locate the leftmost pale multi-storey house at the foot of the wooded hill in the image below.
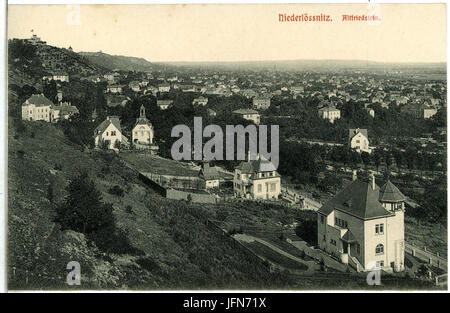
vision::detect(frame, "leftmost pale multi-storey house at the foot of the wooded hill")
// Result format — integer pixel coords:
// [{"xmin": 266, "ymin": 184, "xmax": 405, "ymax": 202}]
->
[{"xmin": 22, "ymin": 94, "xmax": 53, "ymax": 122}]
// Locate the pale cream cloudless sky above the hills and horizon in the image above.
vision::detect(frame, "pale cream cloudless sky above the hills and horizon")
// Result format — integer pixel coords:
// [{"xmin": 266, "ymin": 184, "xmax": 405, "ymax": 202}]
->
[{"xmin": 8, "ymin": 4, "xmax": 447, "ymax": 63}]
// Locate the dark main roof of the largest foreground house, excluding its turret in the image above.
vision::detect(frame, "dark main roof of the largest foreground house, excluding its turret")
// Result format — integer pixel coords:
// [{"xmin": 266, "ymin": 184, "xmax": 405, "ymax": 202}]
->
[{"xmin": 318, "ymin": 179, "xmax": 393, "ymax": 219}]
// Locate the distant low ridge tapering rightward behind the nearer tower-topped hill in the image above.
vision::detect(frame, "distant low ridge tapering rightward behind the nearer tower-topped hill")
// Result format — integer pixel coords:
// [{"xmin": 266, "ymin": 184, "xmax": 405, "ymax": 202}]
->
[{"xmin": 79, "ymin": 52, "xmax": 157, "ymax": 72}]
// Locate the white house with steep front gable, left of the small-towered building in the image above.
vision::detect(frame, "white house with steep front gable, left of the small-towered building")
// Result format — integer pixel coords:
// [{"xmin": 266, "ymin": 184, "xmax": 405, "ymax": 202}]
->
[{"xmin": 94, "ymin": 116, "xmax": 128, "ymax": 150}]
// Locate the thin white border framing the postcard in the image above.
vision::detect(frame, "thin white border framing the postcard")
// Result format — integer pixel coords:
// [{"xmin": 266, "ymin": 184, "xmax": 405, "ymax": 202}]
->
[{"xmin": 0, "ymin": 0, "xmax": 450, "ymax": 293}]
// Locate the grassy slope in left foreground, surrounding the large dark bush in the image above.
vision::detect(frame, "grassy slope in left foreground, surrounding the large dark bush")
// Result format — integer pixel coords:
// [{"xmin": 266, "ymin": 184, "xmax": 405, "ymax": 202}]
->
[{"xmin": 8, "ymin": 120, "xmax": 302, "ymax": 289}]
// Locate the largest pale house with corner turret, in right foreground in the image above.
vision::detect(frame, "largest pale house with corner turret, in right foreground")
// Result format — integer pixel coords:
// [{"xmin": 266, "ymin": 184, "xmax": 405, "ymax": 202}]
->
[{"xmin": 317, "ymin": 175, "xmax": 406, "ymax": 271}]
